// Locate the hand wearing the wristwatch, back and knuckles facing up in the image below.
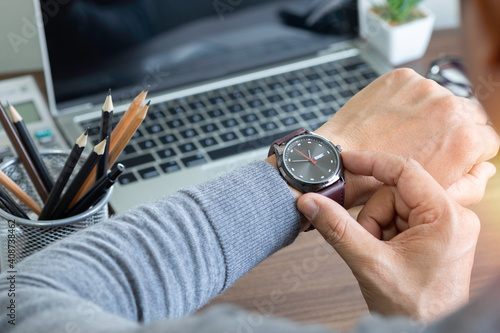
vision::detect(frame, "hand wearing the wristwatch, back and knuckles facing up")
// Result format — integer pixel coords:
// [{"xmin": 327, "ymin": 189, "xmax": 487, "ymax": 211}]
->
[{"xmin": 315, "ymin": 69, "xmax": 499, "ymax": 208}]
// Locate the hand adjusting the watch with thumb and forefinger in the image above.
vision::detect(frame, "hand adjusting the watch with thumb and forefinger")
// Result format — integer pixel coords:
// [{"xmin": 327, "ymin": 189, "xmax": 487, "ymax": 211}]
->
[{"xmin": 297, "ymin": 152, "xmax": 495, "ymax": 322}]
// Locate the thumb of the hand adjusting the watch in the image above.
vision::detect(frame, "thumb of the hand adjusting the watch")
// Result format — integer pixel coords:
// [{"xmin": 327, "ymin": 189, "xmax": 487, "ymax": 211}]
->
[{"xmin": 297, "ymin": 193, "xmax": 380, "ymax": 262}]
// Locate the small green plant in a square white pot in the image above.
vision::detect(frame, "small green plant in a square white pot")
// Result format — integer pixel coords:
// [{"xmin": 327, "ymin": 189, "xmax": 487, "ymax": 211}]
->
[{"xmin": 359, "ymin": 0, "xmax": 435, "ymax": 66}]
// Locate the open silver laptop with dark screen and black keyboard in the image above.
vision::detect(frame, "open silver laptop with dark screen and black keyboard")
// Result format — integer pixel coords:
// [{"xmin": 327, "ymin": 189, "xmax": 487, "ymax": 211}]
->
[{"xmin": 34, "ymin": 0, "xmax": 391, "ymax": 212}]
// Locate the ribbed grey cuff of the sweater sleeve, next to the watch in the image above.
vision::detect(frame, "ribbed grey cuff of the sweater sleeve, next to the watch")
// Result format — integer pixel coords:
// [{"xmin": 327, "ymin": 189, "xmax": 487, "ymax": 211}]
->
[{"xmin": 186, "ymin": 161, "xmax": 300, "ymax": 290}]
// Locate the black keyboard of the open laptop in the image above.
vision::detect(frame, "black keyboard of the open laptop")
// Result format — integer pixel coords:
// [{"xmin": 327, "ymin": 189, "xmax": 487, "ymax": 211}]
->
[{"xmin": 80, "ymin": 56, "xmax": 378, "ymax": 185}]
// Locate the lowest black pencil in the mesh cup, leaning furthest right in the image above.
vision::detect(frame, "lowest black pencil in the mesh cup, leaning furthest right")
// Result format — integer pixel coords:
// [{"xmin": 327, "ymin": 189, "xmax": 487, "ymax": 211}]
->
[{"xmin": 68, "ymin": 163, "xmax": 125, "ymax": 216}]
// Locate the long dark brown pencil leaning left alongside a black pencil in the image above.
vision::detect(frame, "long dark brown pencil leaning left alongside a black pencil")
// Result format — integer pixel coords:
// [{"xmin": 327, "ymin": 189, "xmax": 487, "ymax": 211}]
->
[{"xmin": 0, "ymin": 103, "xmax": 49, "ymax": 202}]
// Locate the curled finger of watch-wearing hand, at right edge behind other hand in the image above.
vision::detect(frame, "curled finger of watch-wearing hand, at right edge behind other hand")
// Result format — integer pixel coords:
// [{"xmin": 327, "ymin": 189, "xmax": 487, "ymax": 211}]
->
[{"xmin": 446, "ymin": 162, "xmax": 496, "ymax": 207}]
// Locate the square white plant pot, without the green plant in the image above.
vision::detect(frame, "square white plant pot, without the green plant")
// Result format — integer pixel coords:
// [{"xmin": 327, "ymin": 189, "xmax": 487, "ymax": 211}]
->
[{"xmin": 362, "ymin": 6, "xmax": 435, "ymax": 66}]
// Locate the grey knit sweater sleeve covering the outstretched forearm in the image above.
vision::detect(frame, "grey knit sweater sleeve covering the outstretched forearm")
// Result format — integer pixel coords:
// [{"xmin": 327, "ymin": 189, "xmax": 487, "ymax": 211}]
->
[{"xmin": 0, "ymin": 162, "xmax": 300, "ymax": 321}]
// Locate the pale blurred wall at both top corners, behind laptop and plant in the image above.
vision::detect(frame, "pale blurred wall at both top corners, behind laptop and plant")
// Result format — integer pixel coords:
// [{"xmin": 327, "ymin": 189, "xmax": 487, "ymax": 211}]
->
[{"xmin": 0, "ymin": 0, "xmax": 460, "ymax": 74}]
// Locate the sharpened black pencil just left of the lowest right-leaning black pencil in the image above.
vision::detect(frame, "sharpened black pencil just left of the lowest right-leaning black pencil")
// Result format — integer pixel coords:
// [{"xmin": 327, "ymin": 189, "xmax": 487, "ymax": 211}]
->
[{"xmin": 50, "ymin": 139, "xmax": 107, "ymax": 220}]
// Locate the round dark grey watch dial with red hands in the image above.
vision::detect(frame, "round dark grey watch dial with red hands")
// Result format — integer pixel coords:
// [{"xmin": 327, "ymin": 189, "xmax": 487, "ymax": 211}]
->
[{"xmin": 283, "ymin": 135, "xmax": 339, "ymax": 183}]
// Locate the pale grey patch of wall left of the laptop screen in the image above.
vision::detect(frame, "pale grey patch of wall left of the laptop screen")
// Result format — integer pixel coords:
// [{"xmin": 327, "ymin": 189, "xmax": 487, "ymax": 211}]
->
[{"xmin": 0, "ymin": 0, "xmax": 42, "ymax": 73}]
